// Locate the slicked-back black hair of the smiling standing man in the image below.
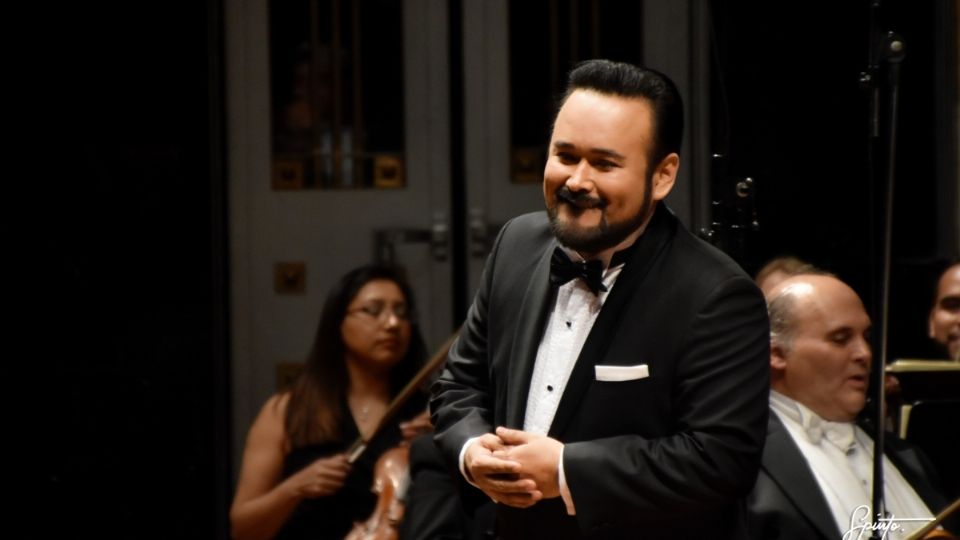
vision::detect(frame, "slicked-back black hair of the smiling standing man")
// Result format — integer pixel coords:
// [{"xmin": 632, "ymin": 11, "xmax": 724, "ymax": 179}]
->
[{"xmin": 560, "ymin": 60, "xmax": 683, "ymax": 168}]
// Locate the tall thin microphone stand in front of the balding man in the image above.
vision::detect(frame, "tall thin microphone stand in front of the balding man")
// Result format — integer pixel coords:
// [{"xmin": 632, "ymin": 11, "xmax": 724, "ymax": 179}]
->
[{"xmin": 861, "ymin": 0, "xmax": 905, "ymax": 540}]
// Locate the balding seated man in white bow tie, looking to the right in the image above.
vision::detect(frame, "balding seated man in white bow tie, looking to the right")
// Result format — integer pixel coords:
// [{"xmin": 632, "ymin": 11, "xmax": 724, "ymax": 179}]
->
[{"xmin": 743, "ymin": 275, "xmax": 946, "ymax": 540}]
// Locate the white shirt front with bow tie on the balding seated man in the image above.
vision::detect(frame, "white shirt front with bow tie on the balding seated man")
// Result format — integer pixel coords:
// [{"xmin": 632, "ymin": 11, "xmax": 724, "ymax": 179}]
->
[{"xmin": 770, "ymin": 391, "xmax": 933, "ymax": 540}]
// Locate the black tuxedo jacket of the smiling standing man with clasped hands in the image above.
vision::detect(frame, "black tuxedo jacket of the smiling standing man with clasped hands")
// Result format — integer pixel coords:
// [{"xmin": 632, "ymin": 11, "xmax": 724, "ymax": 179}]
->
[{"xmin": 431, "ymin": 204, "xmax": 769, "ymax": 539}]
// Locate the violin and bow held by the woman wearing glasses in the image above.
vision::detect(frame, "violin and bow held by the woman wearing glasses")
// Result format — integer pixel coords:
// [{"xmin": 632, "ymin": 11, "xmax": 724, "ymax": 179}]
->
[{"xmin": 344, "ymin": 331, "xmax": 459, "ymax": 540}]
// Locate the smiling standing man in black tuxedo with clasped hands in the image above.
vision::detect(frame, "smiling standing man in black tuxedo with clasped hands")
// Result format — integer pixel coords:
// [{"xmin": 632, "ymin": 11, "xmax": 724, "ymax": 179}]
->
[{"xmin": 431, "ymin": 60, "xmax": 768, "ymax": 539}]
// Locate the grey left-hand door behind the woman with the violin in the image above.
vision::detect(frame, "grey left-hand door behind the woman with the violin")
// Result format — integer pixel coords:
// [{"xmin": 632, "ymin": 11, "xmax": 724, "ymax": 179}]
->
[{"xmin": 226, "ymin": 0, "xmax": 455, "ymax": 467}]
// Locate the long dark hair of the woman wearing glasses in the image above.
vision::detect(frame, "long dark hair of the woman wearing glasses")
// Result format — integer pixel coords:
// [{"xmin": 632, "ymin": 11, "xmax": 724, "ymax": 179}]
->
[{"xmin": 284, "ymin": 265, "xmax": 427, "ymax": 448}]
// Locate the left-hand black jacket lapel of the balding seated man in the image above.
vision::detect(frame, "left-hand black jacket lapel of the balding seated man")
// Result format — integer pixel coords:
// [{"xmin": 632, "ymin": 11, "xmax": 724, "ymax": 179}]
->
[{"xmin": 762, "ymin": 412, "xmax": 838, "ymax": 538}]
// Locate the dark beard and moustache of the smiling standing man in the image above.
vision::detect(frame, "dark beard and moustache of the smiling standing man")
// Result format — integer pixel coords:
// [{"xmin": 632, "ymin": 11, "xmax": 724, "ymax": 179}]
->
[{"xmin": 547, "ymin": 174, "xmax": 653, "ymax": 256}]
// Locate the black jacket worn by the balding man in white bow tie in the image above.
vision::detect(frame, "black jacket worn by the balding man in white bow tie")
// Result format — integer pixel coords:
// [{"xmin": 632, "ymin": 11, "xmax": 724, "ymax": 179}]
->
[{"xmin": 738, "ymin": 413, "xmax": 956, "ymax": 540}]
